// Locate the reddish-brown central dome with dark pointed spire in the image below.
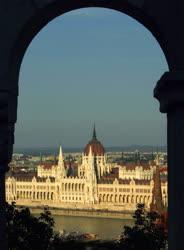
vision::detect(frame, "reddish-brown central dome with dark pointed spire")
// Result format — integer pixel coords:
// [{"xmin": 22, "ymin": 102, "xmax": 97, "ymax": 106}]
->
[{"xmin": 84, "ymin": 126, "xmax": 105, "ymax": 156}]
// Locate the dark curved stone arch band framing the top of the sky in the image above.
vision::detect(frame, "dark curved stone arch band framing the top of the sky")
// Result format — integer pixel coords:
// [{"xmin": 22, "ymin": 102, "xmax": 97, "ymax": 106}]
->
[{"xmin": 9, "ymin": 0, "xmax": 171, "ymax": 105}]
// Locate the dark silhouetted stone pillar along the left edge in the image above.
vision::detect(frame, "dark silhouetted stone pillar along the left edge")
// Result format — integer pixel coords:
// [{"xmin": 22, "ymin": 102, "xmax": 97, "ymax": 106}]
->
[{"xmin": 0, "ymin": 90, "xmax": 17, "ymax": 250}]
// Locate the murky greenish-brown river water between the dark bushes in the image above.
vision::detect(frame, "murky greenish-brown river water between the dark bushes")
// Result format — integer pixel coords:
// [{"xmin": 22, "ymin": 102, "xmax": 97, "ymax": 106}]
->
[{"xmin": 53, "ymin": 215, "xmax": 133, "ymax": 239}]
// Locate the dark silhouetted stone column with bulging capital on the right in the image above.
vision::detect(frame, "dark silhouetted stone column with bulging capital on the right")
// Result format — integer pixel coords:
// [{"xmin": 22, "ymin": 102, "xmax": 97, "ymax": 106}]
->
[{"xmin": 154, "ymin": 71, "xmax": 184, "ymax": 250}]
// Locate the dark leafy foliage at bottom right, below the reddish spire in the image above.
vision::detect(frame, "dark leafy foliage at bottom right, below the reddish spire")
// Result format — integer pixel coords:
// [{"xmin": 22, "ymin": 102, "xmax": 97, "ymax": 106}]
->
[{"xmin": 120, "ymin": 204, "xmax": 167, "ymax": 250}]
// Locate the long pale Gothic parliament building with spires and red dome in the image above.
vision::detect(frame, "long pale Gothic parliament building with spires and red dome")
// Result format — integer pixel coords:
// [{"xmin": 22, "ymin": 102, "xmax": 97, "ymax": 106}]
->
[{"xmin": 6, "ymin": 128, "xmax": 167, "ymax": 211}]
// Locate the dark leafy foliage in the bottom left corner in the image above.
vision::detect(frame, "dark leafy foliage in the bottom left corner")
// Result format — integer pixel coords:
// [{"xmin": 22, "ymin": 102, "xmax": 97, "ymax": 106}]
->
[{"xmin": 6, "ymin": 204, "xmax": 54, "ymax": 250}]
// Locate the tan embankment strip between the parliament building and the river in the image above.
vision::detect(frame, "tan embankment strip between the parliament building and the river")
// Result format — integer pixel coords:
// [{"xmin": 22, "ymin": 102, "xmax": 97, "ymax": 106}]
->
[{"xmin": 29, "ymin": 207, "xmax": 133, "ymax": 220}]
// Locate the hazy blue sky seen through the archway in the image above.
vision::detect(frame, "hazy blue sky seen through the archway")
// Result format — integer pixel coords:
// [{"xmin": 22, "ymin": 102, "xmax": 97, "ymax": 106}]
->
[{"xmin": 15, "ymin": 8, "xmax": 168, "ymax": 147}]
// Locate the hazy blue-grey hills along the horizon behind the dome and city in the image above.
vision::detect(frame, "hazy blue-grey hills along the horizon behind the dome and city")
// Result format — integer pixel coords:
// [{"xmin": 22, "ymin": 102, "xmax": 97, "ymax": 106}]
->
[{"xmin": 14, "ymin": 145, "xmax": 167, "ymax": 155}]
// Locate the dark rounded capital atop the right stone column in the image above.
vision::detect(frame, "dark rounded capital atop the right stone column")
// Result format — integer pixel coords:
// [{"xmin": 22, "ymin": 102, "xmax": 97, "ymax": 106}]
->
[{"xmin": 154, "ymin": 71, "xmax": 184, "ymax": 113}]
